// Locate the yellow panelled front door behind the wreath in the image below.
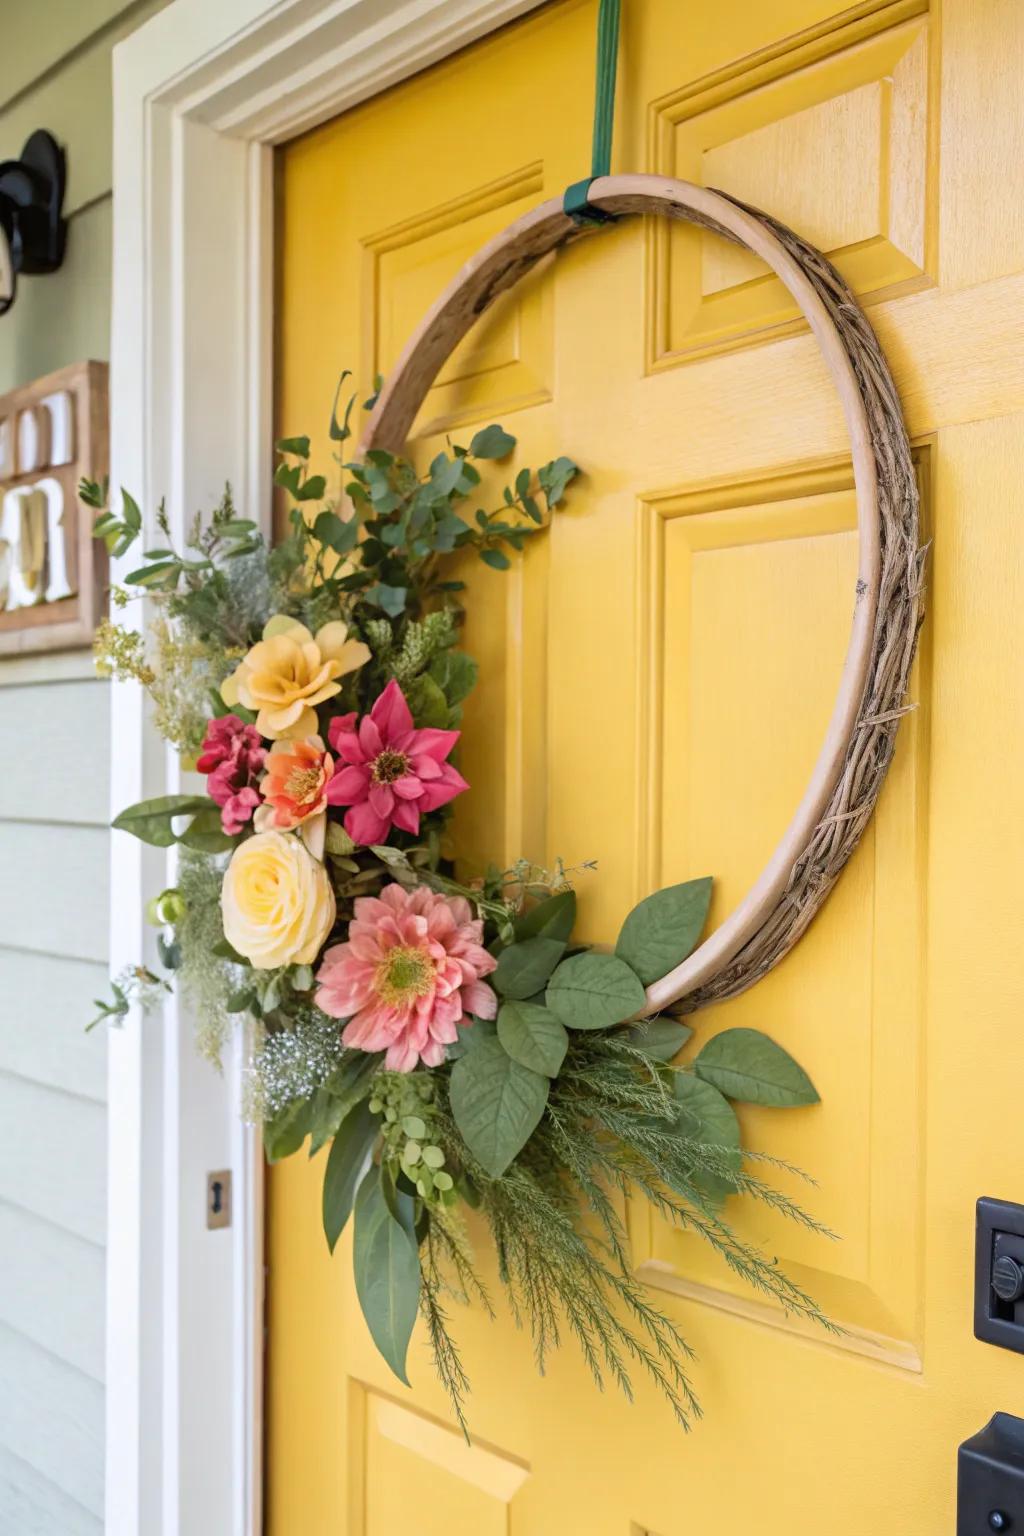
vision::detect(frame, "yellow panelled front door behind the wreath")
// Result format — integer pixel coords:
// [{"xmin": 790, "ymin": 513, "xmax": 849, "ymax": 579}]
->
[{"xmin": 267, "ymin": 0, "xmax": 1024, "ymax": 1536}]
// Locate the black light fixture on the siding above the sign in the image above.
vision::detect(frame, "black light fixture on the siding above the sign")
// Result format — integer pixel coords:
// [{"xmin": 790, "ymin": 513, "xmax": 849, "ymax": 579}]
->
[{"xmin": 0, "ymin": 129, "xmax": 66, "ymax": 315}]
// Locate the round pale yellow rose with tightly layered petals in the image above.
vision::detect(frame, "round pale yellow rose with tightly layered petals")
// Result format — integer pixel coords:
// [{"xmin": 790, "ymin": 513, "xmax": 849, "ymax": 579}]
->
[{"xmin": 221, "ymin": 833, "xmax": 335, "ymax": 971}]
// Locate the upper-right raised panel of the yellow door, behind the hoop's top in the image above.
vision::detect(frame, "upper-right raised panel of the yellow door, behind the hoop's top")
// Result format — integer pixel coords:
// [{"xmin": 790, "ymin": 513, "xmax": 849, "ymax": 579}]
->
[{"xmin": 648, "ymin": 0, "xmax": 938, "ymax": 367}]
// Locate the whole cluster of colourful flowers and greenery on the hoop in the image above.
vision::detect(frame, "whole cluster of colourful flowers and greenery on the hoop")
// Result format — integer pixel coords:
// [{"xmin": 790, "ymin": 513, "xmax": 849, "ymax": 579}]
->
[{"xmin": 88, "ymin": 386, "xmax": 831, "ymax": 1430}]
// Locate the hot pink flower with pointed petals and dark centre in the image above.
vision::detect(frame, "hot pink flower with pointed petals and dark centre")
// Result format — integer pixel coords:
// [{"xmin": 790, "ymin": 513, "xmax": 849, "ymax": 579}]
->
[{"xmin": 327, "ymin": 682, "xmax": 470, "ymax": 843}]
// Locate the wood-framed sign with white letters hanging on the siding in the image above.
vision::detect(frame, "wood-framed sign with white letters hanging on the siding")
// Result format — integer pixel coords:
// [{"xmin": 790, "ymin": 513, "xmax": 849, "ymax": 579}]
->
[{"xmin": 0, "ymin": 362, "xmax": 107, "ymax": 656}]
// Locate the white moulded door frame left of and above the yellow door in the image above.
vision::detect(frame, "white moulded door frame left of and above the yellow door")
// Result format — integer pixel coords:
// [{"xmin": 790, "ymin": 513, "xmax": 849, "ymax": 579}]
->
[{"xmin": 106, "ymin": 0, "xmax": 539, "ymax": 1536}]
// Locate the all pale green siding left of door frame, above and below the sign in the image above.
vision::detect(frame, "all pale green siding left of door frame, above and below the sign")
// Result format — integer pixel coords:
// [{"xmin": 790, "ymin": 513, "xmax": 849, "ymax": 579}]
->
[{"xmin": 0, "ymin": 0, "xmax": 164, "ymax": 1536}]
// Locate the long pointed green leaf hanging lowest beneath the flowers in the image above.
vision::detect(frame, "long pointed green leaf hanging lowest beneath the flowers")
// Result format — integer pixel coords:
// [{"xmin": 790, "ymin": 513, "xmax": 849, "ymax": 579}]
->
[{"xmin": 353, "ymin": 1167, "xmax": 419, "ymax": 1385}]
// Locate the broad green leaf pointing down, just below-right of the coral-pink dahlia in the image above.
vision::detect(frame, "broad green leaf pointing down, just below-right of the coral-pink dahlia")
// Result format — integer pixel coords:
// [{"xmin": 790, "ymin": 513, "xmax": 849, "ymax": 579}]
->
[{"xmin": 448, "ymin": 1035, "xmax": 550, "ymax": 1178}]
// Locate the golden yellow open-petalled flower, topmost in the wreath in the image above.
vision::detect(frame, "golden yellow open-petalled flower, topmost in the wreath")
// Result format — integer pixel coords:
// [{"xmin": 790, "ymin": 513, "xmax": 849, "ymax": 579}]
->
[{"xmin": 221, "ymin": 613, "xmax": 370, "ymax": 742}]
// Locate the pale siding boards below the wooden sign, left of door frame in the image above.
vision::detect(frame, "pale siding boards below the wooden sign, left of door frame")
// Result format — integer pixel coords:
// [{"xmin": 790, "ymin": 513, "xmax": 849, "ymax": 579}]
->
[{"xmin": 0, "ymin": 659, "xmax": 109, "ymax": 1511}]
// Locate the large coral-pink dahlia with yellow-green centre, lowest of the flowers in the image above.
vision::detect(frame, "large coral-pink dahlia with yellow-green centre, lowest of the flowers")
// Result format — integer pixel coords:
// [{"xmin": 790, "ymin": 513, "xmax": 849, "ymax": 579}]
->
[{"xmin": 316, "ymin": 885, "xmax": 497, "ymax": 1072}]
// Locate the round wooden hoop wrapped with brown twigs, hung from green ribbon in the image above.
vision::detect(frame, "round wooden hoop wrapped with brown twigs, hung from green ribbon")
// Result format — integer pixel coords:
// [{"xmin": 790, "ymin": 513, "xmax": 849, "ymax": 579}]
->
[{"xmin": 362, "ymin": 175, "xmax": 924, "ymax": 1012}]
